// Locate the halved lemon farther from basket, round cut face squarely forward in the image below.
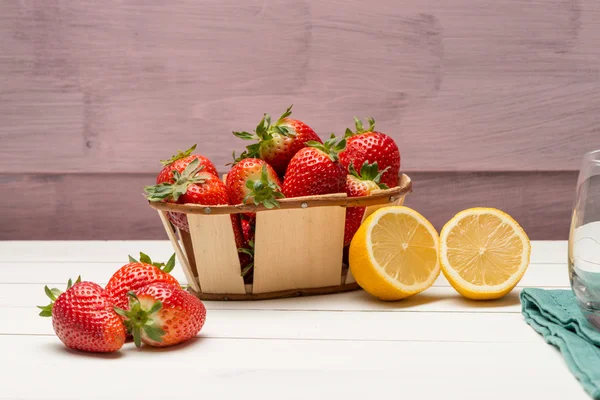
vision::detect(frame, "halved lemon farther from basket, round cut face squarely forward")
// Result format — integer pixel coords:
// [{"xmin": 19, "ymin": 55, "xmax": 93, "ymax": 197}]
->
[{"xmin": 440, "ymin": 208, "xmax": 531, "ymax": 300}]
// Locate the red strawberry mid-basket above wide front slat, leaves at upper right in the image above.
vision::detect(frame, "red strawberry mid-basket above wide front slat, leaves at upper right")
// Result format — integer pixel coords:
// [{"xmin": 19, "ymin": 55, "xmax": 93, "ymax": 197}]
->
[{"xmin": 282, "ymin": 135, "xmax": 346, "ymax": 197}]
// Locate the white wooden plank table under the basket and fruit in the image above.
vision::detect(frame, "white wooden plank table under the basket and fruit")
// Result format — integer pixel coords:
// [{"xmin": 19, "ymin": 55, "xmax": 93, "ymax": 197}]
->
[{"xmin": 0, "ymin": 241, "xmax": 588, "ymax": 400}]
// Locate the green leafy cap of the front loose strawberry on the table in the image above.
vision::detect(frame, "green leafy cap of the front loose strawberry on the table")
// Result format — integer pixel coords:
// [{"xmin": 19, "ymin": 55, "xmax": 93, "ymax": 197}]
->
[{"xmin": 113, "ymin": 291, "xmax": 166, "ymax": 348}]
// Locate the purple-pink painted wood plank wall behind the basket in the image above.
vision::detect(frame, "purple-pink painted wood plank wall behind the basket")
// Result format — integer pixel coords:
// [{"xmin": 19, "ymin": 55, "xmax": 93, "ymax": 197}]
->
[{"xmin": 0, "ymin": 0, "xmax": 600, "ymax": 239}]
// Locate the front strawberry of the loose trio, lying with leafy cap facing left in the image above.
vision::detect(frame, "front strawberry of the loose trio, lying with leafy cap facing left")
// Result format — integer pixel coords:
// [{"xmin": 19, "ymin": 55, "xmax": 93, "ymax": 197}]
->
[{"xmin": 115, "ymin": 282, "xmax": 206, "ymax": 347}]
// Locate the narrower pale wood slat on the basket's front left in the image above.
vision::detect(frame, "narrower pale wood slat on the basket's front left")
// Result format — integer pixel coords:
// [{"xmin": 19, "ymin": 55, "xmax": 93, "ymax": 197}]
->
[{"xmin": 187, "ymin": 214, "xmax": 246, "ymax": 294}]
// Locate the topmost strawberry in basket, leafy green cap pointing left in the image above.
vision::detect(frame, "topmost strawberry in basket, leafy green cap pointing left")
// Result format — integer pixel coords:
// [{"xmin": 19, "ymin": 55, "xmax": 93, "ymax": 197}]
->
[{"xmin": 233, "ymin": 106, "xmax": 321, "ymax": 176}]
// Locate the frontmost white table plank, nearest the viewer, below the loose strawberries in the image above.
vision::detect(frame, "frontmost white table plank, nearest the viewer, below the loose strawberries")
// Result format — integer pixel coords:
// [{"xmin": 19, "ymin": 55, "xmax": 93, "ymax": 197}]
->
[{"xmin": 0, "ymin": 336, "xmax": 589, "ymax": 400}]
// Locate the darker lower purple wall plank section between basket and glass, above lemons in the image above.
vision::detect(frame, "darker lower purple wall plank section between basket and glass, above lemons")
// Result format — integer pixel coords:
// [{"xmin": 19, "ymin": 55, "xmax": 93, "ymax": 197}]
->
[{"xmin": 405, "ymin": 172, "xmax": 577, "ymax": 239}]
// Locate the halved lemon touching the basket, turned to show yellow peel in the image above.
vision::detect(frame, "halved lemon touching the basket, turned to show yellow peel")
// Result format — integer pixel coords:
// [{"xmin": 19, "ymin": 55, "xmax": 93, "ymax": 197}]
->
[{"xmin": 349, "ymin": 206, "xmax": 440, "ymax": 300}]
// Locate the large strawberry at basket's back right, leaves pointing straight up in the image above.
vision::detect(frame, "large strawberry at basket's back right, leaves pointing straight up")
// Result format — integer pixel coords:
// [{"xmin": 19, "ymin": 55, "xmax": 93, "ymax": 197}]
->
[{"xmin": 340, "ymin": 118, "xmax": 400, "ymax": 187}]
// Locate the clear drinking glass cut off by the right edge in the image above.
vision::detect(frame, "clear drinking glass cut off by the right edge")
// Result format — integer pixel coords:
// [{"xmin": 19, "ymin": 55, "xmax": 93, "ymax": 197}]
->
[{"xmin": 569, "ymin": 150, "xmax": 600, "ymax": 330}]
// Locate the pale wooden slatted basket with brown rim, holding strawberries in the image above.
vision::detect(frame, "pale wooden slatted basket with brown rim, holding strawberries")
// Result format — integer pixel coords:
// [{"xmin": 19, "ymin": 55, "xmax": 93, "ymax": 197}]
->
[{"xmin": 150, "ymin": 174, "xmax": 412, "ymax": 300}]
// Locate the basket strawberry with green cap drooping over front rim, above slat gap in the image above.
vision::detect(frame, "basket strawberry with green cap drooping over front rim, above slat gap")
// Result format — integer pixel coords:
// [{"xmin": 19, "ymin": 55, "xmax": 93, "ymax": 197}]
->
[{"xmin": 226, "ymin": 158, "xmax": 283, "ymax": 208}]
